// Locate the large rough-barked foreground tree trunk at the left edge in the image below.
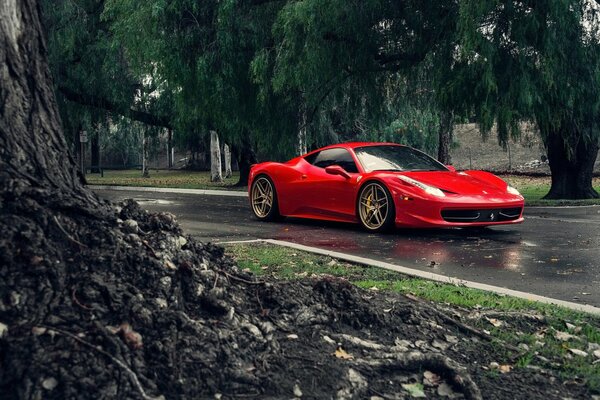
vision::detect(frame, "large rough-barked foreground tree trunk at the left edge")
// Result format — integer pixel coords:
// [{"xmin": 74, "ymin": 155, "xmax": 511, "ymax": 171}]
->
[{"xmin": 0, "ymin": 0, "xmax": 99, "ymax": 211}]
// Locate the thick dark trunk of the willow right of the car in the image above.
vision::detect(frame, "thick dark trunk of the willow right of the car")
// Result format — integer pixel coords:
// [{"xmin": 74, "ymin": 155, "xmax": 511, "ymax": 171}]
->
[{"xmin": 544, "ymin": 132, "xmax": 600, "ymax": 199}]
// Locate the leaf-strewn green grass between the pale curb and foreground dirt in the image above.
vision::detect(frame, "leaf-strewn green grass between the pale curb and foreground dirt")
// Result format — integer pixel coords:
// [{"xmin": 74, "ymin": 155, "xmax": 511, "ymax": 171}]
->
[{"xmin": 226, "ymin": 244, "xmax": 600, "ymax": 393}]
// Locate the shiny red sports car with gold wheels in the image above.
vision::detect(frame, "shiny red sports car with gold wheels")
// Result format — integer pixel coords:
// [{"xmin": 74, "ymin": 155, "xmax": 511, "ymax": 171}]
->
[{"xmin": 248, "ymin": 142, "xmax": 524, "ymax": 231}]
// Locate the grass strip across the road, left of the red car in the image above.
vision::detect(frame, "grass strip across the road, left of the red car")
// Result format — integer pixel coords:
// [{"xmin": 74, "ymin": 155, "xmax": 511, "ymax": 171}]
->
[{"xmin": 86, "ymin": 169, "xmax": 245, "ymax": 190}]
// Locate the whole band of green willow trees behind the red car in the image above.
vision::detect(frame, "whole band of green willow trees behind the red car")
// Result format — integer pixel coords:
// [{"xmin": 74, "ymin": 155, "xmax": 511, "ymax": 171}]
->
[{"xmin": 42, "ymin": 0, "xmax": 600, "ymax": 198}]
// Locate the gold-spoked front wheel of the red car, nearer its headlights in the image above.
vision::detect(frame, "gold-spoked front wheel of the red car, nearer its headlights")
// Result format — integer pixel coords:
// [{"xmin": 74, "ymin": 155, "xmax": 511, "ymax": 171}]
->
[{"xmin": 357, "ymin": 182, "xmax": 396, "ymax": 232}]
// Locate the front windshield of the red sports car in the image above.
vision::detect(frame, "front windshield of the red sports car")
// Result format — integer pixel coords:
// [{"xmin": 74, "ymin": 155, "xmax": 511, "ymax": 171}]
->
[{"xmin": 354, "ymin": 145, "xmax": 448, "ymax": 172}]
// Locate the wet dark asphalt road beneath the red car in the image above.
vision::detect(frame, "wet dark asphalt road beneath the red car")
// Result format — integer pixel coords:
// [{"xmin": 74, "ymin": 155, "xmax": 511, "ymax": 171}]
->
[{"xmin": 96, "ymin": 190, "xmax": 600, "ymax": 307}]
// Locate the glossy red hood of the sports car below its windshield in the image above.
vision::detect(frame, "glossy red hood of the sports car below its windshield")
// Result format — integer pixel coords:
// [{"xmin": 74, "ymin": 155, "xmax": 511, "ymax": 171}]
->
[{"xmin": 401, "ymin": 171, "xmax": 506, "ymax": 196}]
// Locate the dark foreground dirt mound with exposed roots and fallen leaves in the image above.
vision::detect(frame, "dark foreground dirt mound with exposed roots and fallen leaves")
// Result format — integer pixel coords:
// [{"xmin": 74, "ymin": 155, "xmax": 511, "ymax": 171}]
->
[{"xmin": 0, "ymin": 201, "xmax": 587, "ymax": 399}]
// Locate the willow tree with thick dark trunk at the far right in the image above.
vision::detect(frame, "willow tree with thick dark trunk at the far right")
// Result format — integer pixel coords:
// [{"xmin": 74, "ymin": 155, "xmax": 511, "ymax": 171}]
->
[{"xmin": 454, "ymin": 0, "xmax": 600, "ymax": 199}]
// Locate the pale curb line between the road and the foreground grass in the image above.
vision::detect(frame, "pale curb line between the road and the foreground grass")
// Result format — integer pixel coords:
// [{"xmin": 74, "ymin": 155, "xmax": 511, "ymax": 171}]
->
[{"xmin": 217, "ymin": 239, "xmax": 600, "ymax": 315}]
